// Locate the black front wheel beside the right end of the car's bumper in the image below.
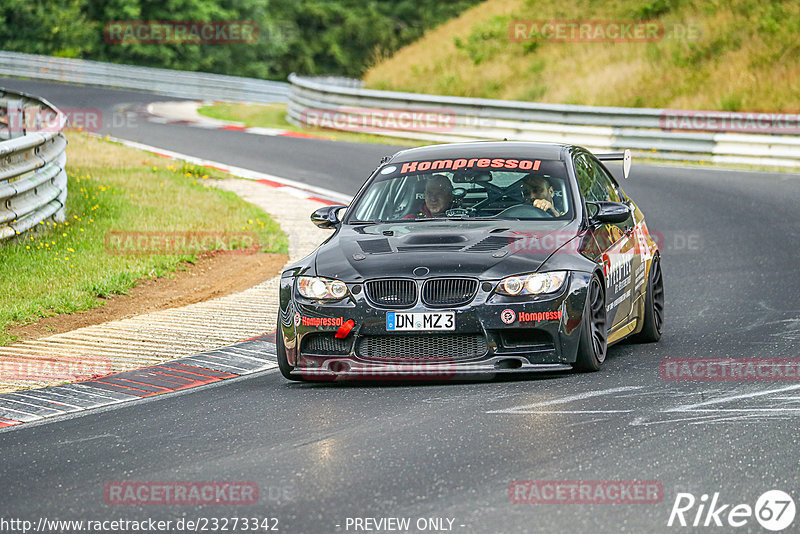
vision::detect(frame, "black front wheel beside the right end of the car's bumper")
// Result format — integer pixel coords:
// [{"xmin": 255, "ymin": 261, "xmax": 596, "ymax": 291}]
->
[{"xmin": 572, "ymin": 275, "xmax": 608, "ymax": 372}]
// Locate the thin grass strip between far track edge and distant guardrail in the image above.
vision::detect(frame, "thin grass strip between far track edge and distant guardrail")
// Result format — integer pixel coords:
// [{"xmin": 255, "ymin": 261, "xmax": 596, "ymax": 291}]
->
[{"xmin": 197, "ymin": 103, "xmax": 422, "ymax": 147}]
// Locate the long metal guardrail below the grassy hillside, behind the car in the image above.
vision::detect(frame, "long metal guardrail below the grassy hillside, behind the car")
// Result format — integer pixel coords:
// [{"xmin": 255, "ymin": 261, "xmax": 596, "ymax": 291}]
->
[{"xmin": 287, "ymin": 74, "xmax": 800, "ymax": 168}]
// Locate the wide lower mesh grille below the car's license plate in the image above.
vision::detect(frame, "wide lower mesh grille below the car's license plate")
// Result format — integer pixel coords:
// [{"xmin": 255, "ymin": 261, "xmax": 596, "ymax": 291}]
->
[{"xmin": 356, "ymin": 334, "xmax": 488, "ymax": 362}]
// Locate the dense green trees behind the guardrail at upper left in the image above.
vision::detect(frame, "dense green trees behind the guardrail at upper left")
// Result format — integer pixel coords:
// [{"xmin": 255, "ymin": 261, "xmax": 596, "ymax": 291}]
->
[{"xmin": 0, "ymin": 0, "xmax": 479, "ymax": 79}]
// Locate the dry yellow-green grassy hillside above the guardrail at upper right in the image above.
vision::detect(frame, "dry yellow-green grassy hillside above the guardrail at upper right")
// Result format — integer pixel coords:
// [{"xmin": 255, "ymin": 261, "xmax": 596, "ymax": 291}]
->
[{"xmin": 365, "ymin": 0, "xmax": 800, "ymax": 112}]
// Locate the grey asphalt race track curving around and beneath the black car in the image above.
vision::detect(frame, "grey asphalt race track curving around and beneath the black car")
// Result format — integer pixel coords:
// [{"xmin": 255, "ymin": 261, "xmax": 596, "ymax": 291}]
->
[{"xmin": 0, "ymin": 79, "xmax": 800, "ymax": 533}]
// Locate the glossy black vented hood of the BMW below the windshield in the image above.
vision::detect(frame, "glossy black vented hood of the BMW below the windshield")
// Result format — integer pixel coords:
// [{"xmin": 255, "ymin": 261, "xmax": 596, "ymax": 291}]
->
[{"xmin": 315, "ymin": 221, "xmax": 577, "ymax": 282}]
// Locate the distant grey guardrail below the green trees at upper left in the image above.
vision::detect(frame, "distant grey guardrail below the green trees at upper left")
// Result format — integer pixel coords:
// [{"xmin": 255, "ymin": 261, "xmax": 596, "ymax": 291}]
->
[{"xmin": 0, "ymin": 51, "xmax": 289, "ymax": 103}]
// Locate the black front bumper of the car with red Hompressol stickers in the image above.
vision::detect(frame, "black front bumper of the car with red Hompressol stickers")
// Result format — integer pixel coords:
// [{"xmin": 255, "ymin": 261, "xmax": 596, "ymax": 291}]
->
[{"xmin": 279, "ymin": 272, "xmax": 590, "ymax": 380}]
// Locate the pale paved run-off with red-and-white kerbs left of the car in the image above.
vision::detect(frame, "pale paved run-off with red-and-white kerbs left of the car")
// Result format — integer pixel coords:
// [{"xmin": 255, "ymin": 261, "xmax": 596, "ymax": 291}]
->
[{"xmin": 0, "ymin": 136, "xmax": 350, "ymax": 430}]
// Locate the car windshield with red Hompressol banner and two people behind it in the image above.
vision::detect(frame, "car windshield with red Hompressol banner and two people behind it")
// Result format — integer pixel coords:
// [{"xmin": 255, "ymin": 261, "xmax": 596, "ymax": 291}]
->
[{"xmin": 347, "ymin": 158, "xmax": 573, "ymax": 223}]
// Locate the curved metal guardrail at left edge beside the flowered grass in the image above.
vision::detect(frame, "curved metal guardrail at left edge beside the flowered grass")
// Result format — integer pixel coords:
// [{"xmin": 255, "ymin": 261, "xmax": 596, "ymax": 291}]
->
[{"xmin": 0, "ymin": 88, "xmax": 67, "ymax": 240}]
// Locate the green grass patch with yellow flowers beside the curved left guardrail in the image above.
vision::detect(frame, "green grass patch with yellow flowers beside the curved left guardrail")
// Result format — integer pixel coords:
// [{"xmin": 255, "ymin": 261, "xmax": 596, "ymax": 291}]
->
[{"xmin": 0, "ymin": 132, "xmax": 288, "ymax": 345}]
